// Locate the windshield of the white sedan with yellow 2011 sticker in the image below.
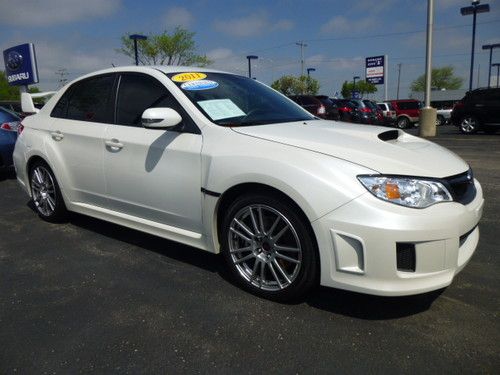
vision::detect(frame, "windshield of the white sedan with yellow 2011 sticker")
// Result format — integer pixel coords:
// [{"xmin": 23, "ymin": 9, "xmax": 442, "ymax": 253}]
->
[{"xmin": 167, "ymin": 72, "xmax": 315, "ymax": 126}]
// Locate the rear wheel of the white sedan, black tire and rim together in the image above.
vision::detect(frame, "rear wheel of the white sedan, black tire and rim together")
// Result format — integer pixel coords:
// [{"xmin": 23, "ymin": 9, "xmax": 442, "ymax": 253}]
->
[{"xmin": 29, "ymin": 160, "xmax": 68, "ymax": 223}]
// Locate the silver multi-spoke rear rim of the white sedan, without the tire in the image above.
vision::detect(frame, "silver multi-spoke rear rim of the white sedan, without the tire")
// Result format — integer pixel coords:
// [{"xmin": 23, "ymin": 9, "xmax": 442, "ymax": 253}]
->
[{"xmin": 31, "ymin": 165, "xmax": 56, "ymax": 216}]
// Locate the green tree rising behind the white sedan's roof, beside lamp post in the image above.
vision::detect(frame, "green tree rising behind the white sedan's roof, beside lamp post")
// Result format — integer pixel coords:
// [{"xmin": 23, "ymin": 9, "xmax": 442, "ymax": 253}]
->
[{"xmin": 117, "ymin": 27, "xmax": 212, "ymax": 66}]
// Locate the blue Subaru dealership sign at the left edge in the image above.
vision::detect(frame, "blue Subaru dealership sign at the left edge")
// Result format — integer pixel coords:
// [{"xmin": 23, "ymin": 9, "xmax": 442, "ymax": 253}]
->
[{"xmin": 3, "ymin": 43, "xmax": 38, "ymax": 86}]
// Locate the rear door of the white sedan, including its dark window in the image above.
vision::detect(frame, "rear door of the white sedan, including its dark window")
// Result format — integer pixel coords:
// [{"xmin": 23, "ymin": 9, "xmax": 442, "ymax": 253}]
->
[{"xmin": 46, "ymin": 74, "xmax": 116, "ymax": 206}]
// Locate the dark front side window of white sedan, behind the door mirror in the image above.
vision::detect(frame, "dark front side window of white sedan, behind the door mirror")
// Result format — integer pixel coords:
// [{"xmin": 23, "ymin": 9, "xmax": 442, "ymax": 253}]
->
[{"xmin": 116, "ymin": 73, "xmax": 179, "ymax": 126}]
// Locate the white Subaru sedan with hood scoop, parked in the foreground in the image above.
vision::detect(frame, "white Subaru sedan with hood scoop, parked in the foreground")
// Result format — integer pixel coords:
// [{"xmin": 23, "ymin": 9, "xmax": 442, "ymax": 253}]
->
[{"xmin": 14, "ymin": 67, "xmax": 484, "ymax": 301}]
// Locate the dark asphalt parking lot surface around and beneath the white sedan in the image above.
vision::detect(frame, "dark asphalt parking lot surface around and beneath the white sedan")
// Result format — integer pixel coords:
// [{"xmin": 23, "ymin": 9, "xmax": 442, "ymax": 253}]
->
[{"xmin": 0, "ymin": 126, "xmax": 500, "ymax": 374}]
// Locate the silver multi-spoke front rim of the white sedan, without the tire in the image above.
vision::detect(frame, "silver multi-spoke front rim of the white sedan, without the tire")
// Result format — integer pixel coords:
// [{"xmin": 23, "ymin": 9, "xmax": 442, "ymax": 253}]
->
[{"xmin": 228, "ymin": 204, "xmax": 302, "ymax": 291}]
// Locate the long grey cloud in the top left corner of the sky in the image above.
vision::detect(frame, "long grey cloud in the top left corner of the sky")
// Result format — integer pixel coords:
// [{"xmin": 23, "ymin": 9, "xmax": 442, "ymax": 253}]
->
[{"xmin": 0, "ymin": 0, "xmax": 121, "ymax": 27}]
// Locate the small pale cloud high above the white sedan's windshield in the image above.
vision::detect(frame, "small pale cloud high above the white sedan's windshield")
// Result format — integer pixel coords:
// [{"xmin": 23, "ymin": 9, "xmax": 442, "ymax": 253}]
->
[{"xmin": 214, "ymin": 11, "xmax": 294, "ymax": 37}]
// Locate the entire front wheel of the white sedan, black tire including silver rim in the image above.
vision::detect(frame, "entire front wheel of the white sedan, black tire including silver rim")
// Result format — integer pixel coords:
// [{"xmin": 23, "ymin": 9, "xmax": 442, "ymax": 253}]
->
[{"xmin": 221, "ymin": 194, "xmax": 319, "ymax": 302}]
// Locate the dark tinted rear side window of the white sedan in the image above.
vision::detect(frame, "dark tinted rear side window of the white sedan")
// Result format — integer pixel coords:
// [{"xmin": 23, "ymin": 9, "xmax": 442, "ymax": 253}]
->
[{"xmin": 64, "ymin": 75, "xmax": 115, "ymax": 123}]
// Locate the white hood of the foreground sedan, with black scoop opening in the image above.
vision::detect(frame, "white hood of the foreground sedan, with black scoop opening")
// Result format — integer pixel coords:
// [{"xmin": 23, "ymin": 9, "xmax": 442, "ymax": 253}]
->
[{"xmin": 233, "ymin": 120, "xmax": 468, "ymax": 178}]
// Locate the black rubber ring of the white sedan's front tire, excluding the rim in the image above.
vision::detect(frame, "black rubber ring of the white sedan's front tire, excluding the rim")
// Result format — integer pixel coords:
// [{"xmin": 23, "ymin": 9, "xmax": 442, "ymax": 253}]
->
[{"xmin": 220, "ymin": 194, "xmax": 319, "ymax": 302}]
